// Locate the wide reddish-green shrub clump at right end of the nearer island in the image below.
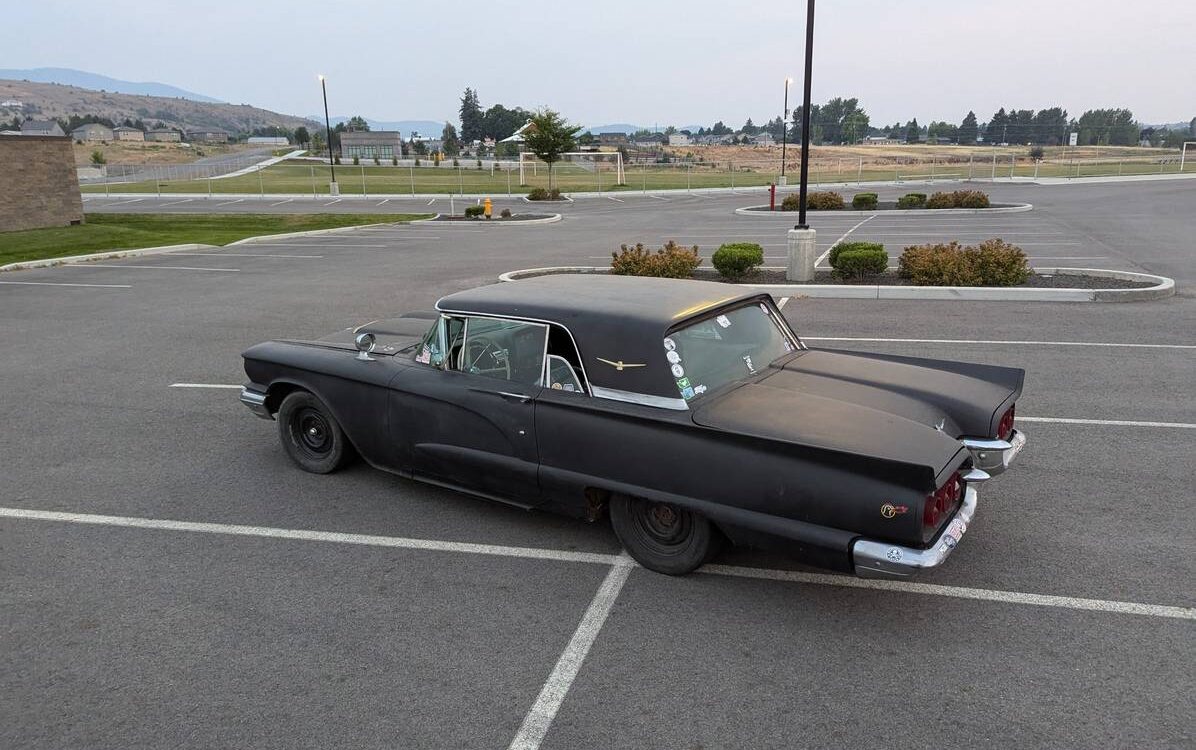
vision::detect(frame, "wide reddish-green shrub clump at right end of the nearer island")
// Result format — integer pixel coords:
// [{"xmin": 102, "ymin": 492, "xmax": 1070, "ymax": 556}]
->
[{"xmin": 898, "ymin": 239, "xmax": 1031, "ymax": 286}]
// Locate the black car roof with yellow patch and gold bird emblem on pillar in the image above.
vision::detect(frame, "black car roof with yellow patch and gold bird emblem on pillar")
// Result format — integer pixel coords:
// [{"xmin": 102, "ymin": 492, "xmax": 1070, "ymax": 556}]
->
[{"xmin": 437, "ymin": 274, "xmax": 764, "ymax": 408}]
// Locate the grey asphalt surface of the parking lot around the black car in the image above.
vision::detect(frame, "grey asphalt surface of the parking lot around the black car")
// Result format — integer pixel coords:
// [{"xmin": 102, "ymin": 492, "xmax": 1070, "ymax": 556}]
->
[{"xmin": 0, "ymin": 182, "xmax": 1196, "ymax": 748}]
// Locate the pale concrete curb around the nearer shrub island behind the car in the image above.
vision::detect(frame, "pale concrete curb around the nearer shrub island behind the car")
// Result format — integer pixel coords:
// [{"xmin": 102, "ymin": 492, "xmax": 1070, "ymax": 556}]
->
[{"xmin": 499, "ymin": 266, "xmax": 1176, "ymax": 303}]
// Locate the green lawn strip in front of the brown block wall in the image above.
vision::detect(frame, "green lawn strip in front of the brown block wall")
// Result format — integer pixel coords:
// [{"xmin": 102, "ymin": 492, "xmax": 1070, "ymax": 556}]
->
[{"xmin": 0, "ymin": 214, "xmax": 432, "ymax": 266}]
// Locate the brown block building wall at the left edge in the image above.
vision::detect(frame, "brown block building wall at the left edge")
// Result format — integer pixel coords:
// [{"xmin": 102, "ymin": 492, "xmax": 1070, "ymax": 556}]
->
[{"xmin": 0, "ymin": 135, "xmax": 83, "ymax": 233}]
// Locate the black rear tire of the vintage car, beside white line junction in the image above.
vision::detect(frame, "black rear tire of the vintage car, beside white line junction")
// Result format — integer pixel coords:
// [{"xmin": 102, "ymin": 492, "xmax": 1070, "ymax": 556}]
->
[{"xmin": 610, "ymin": 495, "xmax": 722, "ymax": 575}]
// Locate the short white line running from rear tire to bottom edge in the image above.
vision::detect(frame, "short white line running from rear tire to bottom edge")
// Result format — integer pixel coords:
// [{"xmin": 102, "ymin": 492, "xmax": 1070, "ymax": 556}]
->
[{"xmin": 509, "ymin": 557, "xmax": 634, "ymax": 750}]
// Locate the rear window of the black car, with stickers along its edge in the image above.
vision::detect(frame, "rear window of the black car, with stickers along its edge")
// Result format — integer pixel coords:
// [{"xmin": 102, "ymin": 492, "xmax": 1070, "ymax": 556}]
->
[{"xmin": 664, "ymin": 303, "xmax": 797, "ymax": 401}]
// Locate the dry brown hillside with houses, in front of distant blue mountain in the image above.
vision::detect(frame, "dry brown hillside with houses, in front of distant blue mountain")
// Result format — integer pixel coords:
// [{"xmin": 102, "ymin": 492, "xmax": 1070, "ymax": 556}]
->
[{"xmin": 0, "ymin": 80, "xmax": 316, "ymax": 134}]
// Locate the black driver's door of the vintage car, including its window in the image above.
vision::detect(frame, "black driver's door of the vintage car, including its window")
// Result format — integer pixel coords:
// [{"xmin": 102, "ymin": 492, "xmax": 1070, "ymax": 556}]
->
[{"xmin": 391, "ymin": 316, "xmax": 548, "ymax": 506}]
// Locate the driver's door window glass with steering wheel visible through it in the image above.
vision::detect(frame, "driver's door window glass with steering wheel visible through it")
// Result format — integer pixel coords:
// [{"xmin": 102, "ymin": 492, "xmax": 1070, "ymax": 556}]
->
[{"xmin": 459, "ymin": 318, "xmax": 548, "ymax": 385}]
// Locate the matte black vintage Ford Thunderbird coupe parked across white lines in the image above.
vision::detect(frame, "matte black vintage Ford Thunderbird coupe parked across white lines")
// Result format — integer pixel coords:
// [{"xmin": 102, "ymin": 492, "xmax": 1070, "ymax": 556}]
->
[{"xmin": 240, "ymin": 275, "xmax": 1025, "ymax": 579}]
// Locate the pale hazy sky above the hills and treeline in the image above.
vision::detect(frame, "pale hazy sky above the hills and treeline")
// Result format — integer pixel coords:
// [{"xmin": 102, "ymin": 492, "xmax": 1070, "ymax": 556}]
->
[{"xmin": 0, "ymin": 0, "xmax": 1196, "ymax": 127}]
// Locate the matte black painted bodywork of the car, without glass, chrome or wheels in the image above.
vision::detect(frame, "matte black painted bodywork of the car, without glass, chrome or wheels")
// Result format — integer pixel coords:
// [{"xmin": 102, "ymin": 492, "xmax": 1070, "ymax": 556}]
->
[{"xmin": 244, "ymin": 276, "xmax": 1024, "ymax": 571}]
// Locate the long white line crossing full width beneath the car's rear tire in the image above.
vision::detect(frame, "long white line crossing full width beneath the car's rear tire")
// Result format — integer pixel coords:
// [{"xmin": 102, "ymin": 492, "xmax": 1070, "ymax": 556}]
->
[{"xmin": 0, "ymin": 507, "xmax": 1196, "ymax": 621}]
